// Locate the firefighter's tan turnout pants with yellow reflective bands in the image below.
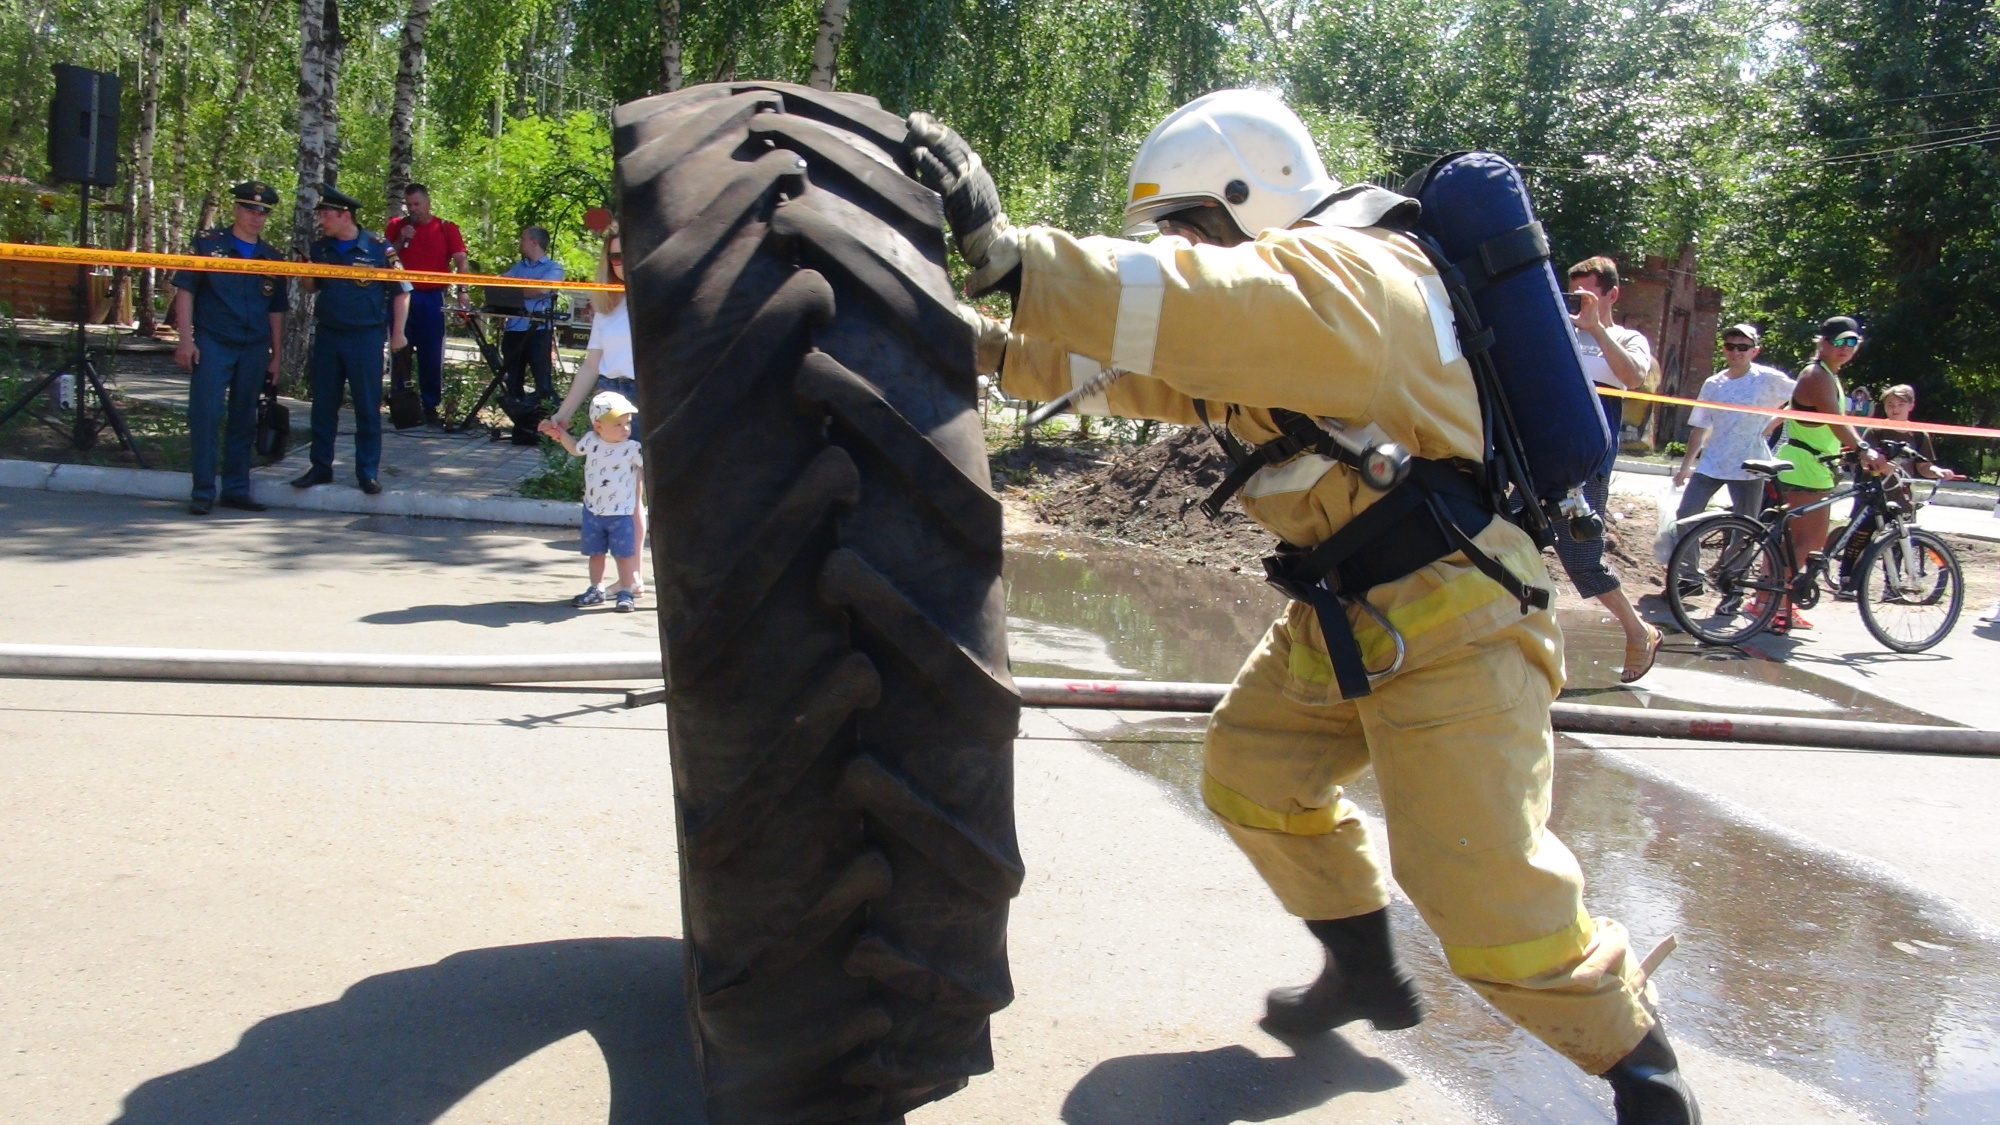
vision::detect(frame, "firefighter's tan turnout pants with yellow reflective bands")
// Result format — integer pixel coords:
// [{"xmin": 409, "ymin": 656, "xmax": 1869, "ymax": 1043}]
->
[{"xmin": 1202, "ymin": 603, "xmax": 1654, "ymax": 1073}]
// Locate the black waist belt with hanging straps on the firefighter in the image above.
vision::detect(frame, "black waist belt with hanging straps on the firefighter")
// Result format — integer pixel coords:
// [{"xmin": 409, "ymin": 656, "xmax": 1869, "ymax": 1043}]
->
[{"xmin": 1264, "ymin": 458, "xmax": 1548, "ymax": 699}]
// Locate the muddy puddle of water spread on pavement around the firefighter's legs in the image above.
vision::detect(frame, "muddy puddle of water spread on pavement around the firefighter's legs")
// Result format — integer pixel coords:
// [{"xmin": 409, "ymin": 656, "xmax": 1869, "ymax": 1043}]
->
[{"xmin": 1008, "ymin": 532, "xmax": 2000, "ymax": 1125}]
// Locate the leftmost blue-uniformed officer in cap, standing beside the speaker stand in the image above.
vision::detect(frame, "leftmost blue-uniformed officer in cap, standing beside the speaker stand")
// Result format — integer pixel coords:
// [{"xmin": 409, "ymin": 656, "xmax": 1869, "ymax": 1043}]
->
[{"xmin": 174, "ymin": 180, "xmax": 292, "ymax": 516}]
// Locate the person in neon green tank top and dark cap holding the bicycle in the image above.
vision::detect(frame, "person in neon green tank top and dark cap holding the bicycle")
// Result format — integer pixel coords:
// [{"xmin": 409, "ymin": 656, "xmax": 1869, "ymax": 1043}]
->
[{"xmin": 1772, "ymin": 316, "xmax": 1884, "ymax": 633}]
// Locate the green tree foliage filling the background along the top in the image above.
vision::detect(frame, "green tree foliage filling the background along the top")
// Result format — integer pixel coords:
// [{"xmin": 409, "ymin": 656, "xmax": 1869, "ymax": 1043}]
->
[{"xmin": 0, "ymin": 0, "xmax": 2000, "ymax": 422}]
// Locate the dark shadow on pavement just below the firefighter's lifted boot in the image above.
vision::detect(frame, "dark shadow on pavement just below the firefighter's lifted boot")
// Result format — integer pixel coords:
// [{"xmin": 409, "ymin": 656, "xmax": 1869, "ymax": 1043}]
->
[{"xmin": 1062, "ymin": 1035, "xmax": 1404, "ymax": 1125}]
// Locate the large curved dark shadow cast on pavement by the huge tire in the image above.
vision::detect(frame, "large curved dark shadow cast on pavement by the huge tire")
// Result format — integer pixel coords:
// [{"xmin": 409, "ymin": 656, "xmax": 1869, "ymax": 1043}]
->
[{"xmin": 114, "ymin": 937, "xmax": 706, "ymax": 1125}]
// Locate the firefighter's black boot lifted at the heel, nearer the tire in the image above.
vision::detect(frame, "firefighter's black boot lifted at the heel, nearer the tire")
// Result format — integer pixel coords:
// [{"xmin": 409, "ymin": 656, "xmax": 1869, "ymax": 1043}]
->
[{"xmin": 1264, "ymin": 909, "xmax": 1424, "ymax": 1035}]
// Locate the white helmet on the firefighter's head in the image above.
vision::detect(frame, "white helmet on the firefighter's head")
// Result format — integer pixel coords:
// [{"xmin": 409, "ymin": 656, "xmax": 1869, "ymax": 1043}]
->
[{"xmin": 1124, "ymin": 90, "xmax": 1340, "ymax": 238}]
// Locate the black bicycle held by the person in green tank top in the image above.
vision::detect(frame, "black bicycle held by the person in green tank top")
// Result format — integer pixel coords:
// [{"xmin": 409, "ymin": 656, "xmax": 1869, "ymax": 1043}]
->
[{"xmin": 1666, "ymin": 440, "xmax": 1966, "ymax": 653}]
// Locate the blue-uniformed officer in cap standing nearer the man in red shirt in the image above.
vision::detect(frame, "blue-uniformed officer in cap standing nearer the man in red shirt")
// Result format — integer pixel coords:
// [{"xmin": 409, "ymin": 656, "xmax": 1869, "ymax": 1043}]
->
[{"xmin": 292, "ymin": 184, "xmax": 410, "ymax": 496}]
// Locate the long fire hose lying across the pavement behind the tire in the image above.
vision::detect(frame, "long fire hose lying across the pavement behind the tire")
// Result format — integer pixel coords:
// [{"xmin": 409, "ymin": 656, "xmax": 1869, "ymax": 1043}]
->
[{"xmin": 0, "ymin": 645, "xmax": 2000, "ymax": 757}]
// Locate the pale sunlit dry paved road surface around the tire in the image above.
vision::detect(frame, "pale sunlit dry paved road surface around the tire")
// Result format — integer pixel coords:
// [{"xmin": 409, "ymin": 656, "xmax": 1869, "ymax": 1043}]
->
[{"xmin": 0, "ymin": 492, "xmax": 2000, "ymax": 1125}]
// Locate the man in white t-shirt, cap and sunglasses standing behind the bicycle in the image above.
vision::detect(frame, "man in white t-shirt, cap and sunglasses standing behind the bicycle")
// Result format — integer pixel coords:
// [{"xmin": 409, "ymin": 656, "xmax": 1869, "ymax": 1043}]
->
[{"xmin": 1674, "ymin": 324, "xmax": 1794, "ymax": 518}]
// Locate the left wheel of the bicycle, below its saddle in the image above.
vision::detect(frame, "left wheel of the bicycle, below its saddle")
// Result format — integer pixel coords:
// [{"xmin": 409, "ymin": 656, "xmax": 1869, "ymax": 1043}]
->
[{"xmin": 1666, "ymin": 516, "xmax": 1784, "ymax": 645}]
